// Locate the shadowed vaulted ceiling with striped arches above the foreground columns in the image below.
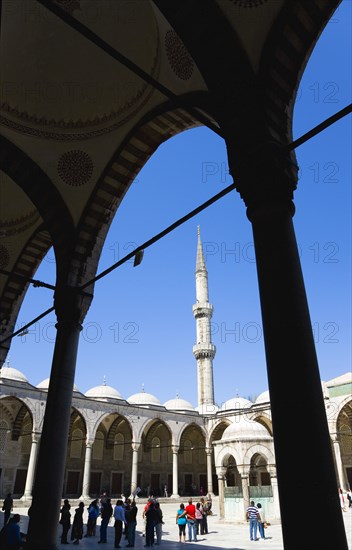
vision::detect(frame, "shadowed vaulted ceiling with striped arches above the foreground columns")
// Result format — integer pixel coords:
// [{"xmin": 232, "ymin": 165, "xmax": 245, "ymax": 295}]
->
[{"xmin": 0, "ymin": 0, "xmax": 340, "ymax": 361}]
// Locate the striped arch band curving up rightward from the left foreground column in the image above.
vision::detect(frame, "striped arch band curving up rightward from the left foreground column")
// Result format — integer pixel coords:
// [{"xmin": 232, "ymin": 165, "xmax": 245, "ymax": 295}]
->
[{"xmin": 73, "ymin": 99, "xmax": 209, "ymax": 292}]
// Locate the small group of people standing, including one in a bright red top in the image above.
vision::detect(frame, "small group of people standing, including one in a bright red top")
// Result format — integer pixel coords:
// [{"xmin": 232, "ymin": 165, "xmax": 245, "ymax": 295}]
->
[{"xmin": 176, "ymin": 495, "xmax": 212, "ymax": 542}]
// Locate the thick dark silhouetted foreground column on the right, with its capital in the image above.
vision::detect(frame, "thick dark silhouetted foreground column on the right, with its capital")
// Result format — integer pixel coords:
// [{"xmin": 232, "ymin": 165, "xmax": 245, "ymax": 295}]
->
[{"xmin": 235, "ymin": 147, "xmax": 347, "ymax": 550}]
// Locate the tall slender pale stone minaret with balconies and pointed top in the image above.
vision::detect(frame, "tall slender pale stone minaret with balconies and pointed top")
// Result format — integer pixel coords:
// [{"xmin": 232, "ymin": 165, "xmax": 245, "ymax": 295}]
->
[{"xmin": 193, "ymin": 226, "xmax": 216, "ymax": 407}]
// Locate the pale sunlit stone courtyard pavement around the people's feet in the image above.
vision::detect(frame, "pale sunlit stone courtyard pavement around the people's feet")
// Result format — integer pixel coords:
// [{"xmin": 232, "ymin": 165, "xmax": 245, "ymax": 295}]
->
[{"xmin": 0, "ymin": 498, "xmax": 352, "ymax": 550}]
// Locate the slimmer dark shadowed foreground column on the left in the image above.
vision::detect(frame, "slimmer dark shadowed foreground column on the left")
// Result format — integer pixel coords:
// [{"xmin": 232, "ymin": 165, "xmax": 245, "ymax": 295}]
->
[{"xmin": 26, "ymin": 287, "xmax": 83, "ymax": 550}]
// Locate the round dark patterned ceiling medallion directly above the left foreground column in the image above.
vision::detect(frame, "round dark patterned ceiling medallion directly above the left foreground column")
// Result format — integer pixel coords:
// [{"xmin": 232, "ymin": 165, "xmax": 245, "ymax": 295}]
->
[{"xmin": 57, "ymin": 149, "xmax": 93, "ymax": 187}]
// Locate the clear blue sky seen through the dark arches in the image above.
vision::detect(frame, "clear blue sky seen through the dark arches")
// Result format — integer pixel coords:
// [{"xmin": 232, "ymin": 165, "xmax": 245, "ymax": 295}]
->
[{"xmin": 4, "ymin": 0, "xmax": 352, "ymax": 406}]
